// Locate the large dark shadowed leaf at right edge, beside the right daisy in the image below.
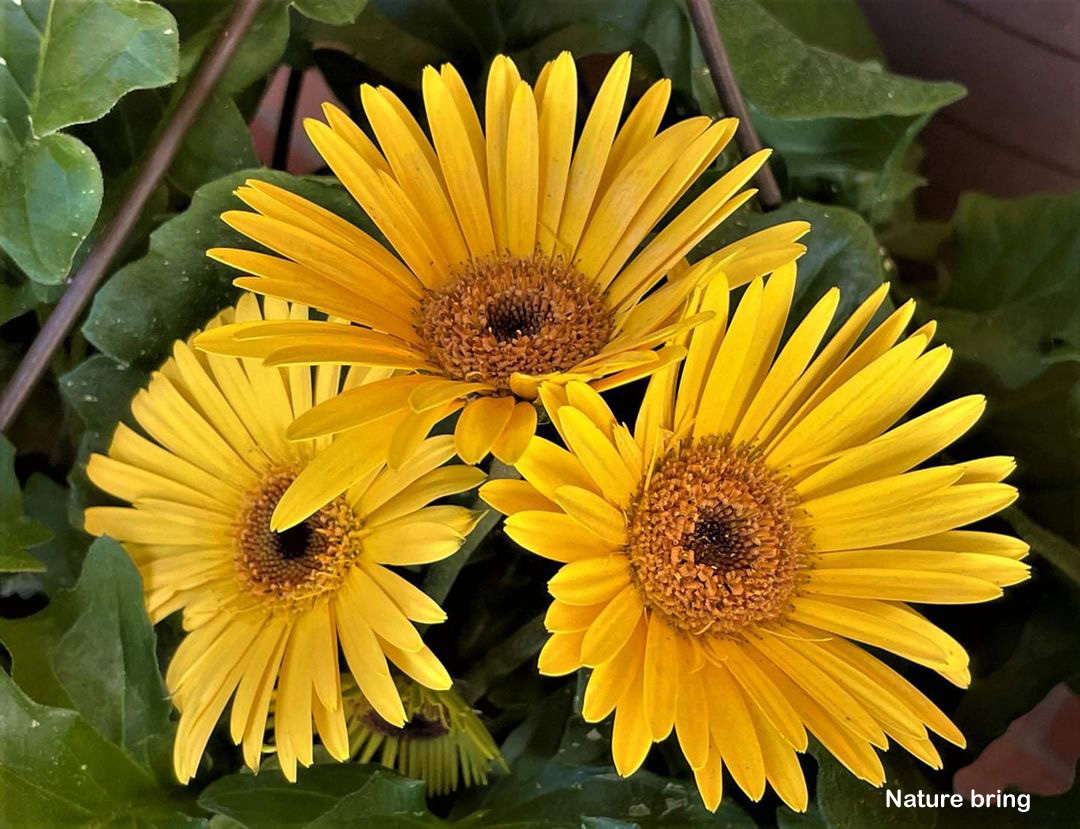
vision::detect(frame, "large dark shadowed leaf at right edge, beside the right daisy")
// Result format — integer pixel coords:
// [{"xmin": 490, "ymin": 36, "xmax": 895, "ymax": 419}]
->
[{"xmin": 919, "ymin": 194, "xmax": 1080, "ymax": 542}]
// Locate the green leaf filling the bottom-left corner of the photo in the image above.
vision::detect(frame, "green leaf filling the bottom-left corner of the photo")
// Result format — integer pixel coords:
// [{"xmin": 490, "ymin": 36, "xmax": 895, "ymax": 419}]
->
[{"xmin": 0, "ymin": 670, "xmax": 206, "ymax": 828}]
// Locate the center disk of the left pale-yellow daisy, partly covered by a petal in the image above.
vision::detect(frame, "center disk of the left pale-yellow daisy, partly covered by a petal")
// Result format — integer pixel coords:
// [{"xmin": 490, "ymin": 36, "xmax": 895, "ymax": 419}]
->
[{"xmin": 233, "ymin": 470, "xmax": 363, "ymax": 604}]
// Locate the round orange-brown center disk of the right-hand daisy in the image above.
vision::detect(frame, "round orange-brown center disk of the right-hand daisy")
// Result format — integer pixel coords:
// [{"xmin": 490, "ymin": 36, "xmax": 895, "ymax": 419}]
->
[{"xmin": 629, "ymin": 437, "xmax": 808, "ymax": 637}]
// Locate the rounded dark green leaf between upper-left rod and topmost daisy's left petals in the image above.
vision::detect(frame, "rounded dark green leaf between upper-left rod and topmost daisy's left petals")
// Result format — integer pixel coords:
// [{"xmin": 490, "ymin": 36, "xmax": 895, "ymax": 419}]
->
[{"xmin": 83, "ymin": 169, "xmax": 375, "ymax": 368}]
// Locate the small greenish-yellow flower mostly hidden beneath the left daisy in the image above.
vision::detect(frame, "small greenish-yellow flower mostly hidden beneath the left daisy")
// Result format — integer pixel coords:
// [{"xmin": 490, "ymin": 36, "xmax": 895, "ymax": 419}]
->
[{"xmin": 341, "ymin": 677, "xmax": 507, "ymax": 794}]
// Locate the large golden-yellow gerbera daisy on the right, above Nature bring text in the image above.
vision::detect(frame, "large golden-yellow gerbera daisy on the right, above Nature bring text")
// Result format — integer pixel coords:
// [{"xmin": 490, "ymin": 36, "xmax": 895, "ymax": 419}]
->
[{"xmin": 481, "ymin": 266, "xmax": 1028, "ymax": 810}]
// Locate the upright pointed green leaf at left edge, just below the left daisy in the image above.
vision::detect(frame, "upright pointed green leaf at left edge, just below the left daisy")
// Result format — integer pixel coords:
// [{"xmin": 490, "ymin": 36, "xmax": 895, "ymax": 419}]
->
[{"xmin": 0, "ymin": 539, "xmax": 172, "ymax": 774}]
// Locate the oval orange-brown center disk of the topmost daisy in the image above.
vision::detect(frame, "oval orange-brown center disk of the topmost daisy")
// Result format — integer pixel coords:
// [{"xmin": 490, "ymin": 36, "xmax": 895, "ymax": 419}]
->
[{"xmin": 416, "ymin": 255, "xmax": 613, "ymax": 391}]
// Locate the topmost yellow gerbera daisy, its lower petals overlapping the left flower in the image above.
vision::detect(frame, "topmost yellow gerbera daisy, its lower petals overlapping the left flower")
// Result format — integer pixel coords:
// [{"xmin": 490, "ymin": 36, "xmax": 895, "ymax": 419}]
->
[{"xmin": 197, "ymin": 53, "xmax": 809, "ymax": 527}]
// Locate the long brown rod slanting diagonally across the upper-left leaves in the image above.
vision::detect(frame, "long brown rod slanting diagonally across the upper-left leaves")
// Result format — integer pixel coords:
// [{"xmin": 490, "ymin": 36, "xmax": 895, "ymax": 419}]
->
[{"xmin": 0, "ymin": 0, "xmax": 264, "ymax": 432}]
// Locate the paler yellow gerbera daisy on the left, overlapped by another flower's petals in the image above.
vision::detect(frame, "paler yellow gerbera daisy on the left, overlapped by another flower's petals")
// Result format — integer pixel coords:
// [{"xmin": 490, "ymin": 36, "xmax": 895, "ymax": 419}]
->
[{"xmin": 79, "ymin": 295, "xmax": 483, "ymax": 783}]
